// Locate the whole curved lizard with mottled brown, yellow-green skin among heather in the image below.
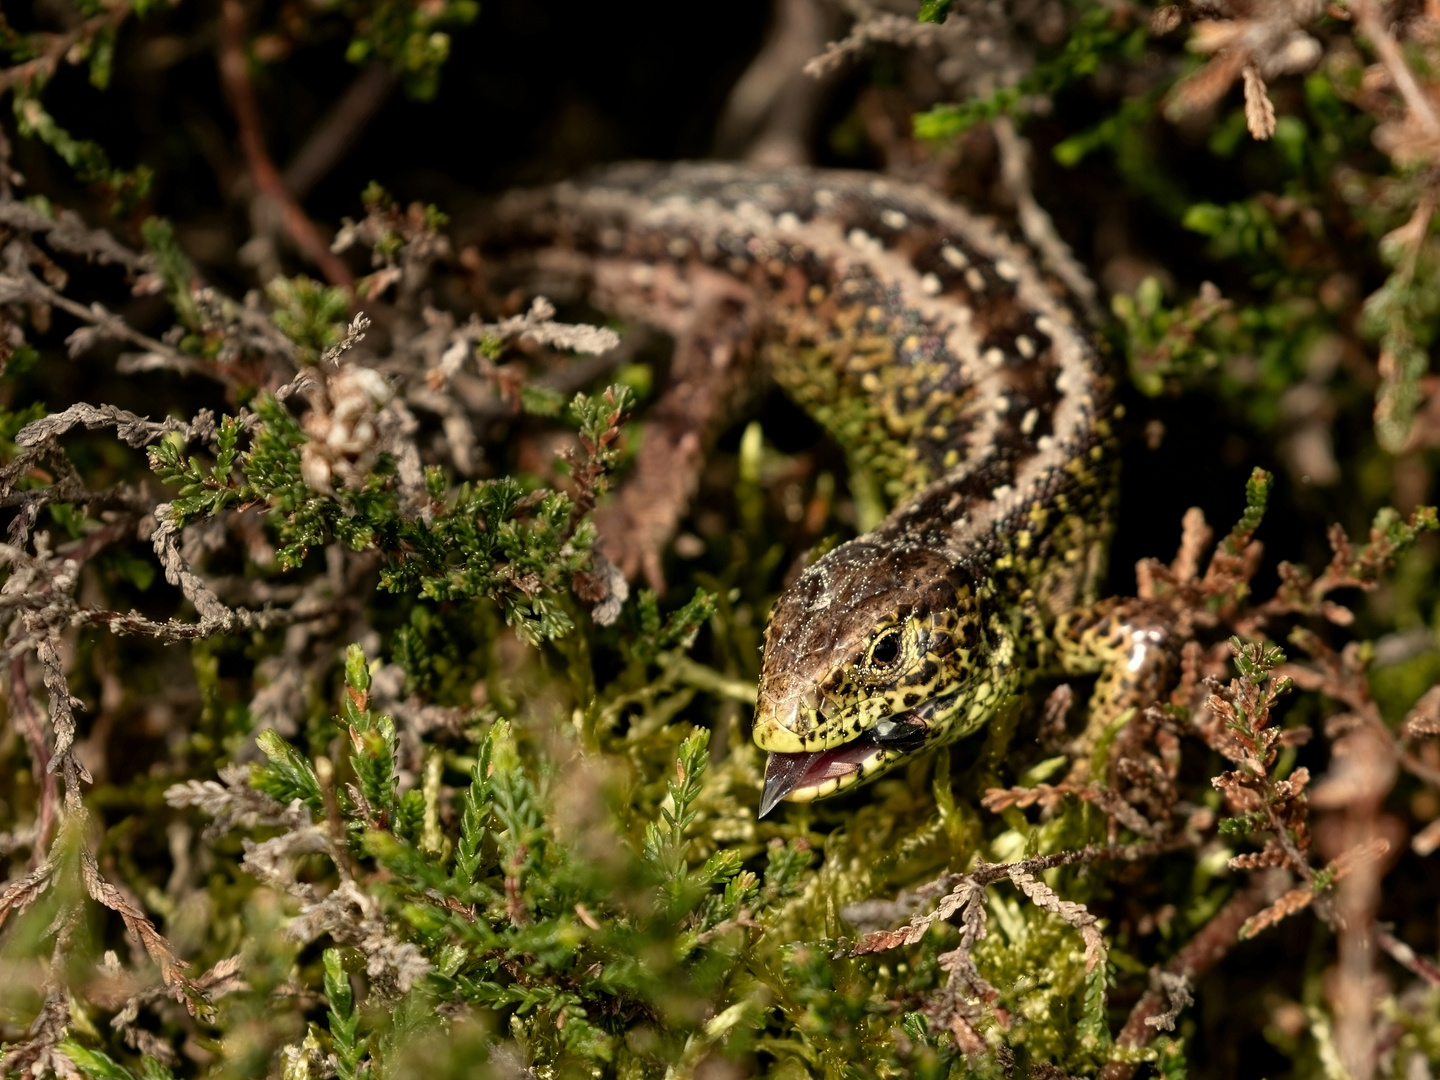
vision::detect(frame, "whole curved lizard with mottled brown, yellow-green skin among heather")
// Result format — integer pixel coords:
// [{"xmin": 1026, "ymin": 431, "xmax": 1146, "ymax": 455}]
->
[{"xmin": 486, "ymin": 166, "xmax": 1164, "ymax": 814}]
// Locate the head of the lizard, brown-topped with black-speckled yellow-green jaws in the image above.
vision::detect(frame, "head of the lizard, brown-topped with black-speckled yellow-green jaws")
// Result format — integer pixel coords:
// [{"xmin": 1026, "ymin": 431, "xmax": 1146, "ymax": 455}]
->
[{"xmin": 755, "ymin": 539, "xmax": 996, "ymax": 816}]
